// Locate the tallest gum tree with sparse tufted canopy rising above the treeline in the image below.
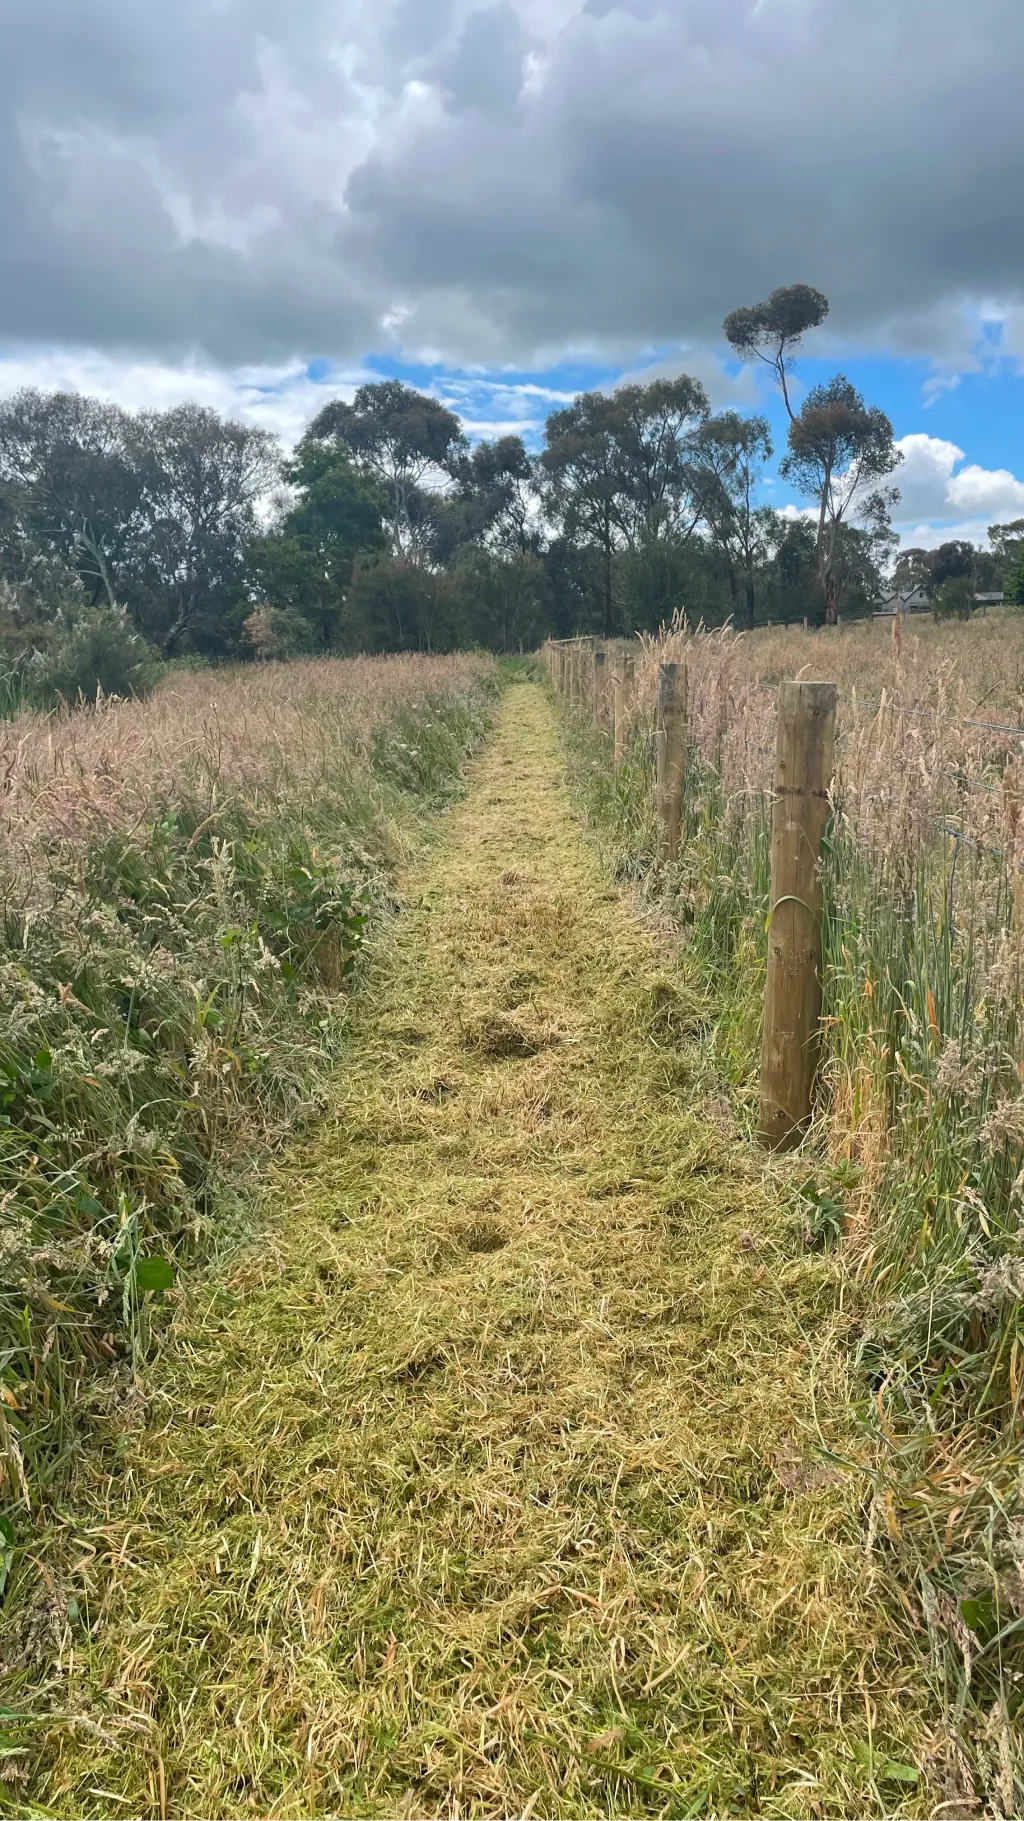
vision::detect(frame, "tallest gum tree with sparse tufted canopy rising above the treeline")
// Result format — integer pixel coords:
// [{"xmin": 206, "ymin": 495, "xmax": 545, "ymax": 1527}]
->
[{"xmin": 723, "ymin": 284, "xmax": 904, "ymax": 626}]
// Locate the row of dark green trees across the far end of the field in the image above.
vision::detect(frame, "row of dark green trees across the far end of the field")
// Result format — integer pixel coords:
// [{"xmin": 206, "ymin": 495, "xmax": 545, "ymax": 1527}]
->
[{"xmin": 0, "ymin": 284, "xmax": 1019, "ymax": 692}]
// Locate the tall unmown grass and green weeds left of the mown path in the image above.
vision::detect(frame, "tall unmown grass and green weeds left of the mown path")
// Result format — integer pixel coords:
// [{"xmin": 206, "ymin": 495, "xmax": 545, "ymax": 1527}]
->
[{"xmin": 0, "ymin": 659, "xmax": 496, "ymax": 1546}]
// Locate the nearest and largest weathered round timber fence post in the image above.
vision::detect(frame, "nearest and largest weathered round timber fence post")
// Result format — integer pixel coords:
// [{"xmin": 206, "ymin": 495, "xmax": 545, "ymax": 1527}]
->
[{"xmin": 762, "ymin": 683, "xmax": 836, "ymax": 1151}]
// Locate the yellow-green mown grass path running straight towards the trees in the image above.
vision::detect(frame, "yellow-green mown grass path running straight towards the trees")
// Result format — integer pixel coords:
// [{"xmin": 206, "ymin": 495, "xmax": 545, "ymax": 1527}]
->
[{"xmin": 33, "ymin": 685, "xmax": 926, "ymax": 1817}]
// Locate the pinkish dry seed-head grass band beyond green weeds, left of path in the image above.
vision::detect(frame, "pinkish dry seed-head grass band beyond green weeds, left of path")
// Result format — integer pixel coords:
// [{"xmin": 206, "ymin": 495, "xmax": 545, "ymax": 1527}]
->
[{"xmin": 0, "ymin": 656, "xmax": 488, "ymax": 892}]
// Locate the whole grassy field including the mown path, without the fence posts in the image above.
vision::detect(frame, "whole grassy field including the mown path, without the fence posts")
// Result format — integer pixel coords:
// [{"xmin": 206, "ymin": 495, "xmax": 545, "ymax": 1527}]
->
[{"xmin": 0, "ymin": 615, "xmax": 1024, "ymax": 1821}]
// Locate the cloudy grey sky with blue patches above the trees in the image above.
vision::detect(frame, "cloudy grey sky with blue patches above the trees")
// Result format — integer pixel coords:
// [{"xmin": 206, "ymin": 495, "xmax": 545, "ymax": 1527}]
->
[{"xmin": 0, "ymin": 0, "xmax": 1024, "ymax": 544}]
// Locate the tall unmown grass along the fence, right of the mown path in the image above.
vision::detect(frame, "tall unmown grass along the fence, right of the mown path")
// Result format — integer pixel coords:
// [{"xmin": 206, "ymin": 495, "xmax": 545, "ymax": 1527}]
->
[{"xmin": 557, "ymin": 614, "xmax": 1024, "ymax": 1814}]
